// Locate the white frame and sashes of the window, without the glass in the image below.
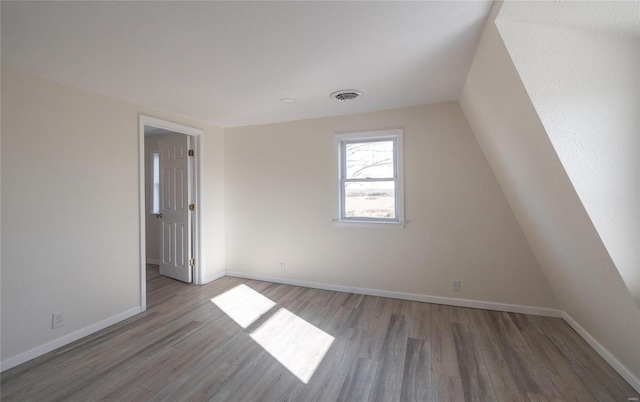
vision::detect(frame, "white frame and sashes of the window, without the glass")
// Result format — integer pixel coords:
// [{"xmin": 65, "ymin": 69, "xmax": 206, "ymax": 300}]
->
[{"xmin": 334, "ymin": 129, "xmax": 406, "ymax": 228}]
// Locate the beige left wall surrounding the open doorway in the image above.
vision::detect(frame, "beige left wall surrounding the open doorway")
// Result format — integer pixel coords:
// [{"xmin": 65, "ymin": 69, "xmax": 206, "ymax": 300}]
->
[{"xmin": 1, "ymin": 67, "xmax": 224, "ymax": 369}]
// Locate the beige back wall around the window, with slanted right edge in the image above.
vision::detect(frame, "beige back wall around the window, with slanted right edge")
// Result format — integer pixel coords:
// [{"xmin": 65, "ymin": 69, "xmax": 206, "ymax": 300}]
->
[{"xmin": 225, "ymin": 102, "xmax": 556, "ymax": 308}]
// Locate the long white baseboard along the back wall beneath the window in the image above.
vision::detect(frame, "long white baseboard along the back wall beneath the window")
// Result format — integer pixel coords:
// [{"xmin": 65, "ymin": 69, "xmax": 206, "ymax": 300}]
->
[{"xmin": 226, "ymin": 271, "xmax": 562, "ymax": 317}]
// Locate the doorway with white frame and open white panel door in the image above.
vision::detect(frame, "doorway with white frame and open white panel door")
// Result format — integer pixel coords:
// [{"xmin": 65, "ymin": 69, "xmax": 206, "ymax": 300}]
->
[{"xmin": 139, "ymin": 115, "xmax": 202, "ymax": 311}]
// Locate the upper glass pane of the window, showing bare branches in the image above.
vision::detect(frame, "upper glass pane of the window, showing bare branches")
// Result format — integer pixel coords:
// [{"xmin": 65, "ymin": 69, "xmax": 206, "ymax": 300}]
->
[{"xmin": 345, "ymin": 141, "xmax": 394, "ymax": 179}]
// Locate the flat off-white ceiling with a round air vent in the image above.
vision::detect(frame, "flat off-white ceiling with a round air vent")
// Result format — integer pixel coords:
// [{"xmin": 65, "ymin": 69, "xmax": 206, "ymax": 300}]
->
[{"xmin": 1, "ymin": 0, "xmax": 492, "ymax": 127}]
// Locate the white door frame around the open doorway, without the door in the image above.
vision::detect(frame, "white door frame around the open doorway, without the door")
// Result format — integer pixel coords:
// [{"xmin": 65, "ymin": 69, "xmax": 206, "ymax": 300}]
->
[{"xmin": 138, "ymin": 114, "xmax": 204, "ymax": 311}]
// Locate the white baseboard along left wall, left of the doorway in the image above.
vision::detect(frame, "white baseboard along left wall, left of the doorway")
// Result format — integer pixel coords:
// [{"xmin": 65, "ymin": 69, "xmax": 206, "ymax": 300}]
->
[{"xmin": 0, "ymin": 306, "xmax": 142, "ymax": 372}]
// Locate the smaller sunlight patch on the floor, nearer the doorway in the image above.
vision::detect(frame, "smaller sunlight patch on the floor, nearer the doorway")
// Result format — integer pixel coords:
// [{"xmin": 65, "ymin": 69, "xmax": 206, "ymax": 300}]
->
[{"xmin": 211, "ymin": 284, "xmax": 276, "ymax": 328}]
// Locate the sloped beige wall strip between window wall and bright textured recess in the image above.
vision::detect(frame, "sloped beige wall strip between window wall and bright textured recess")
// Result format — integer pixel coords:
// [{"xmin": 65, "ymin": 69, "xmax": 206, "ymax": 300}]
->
[{"xmin": 460, "ymin": 6, "xmax": 640, "ymax": 388}]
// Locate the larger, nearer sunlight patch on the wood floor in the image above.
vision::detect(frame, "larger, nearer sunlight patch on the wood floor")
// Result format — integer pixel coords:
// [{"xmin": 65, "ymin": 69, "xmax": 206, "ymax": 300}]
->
[{"xmin": 251, "ymin": 308, "xmax": 334, "ymax": 384}]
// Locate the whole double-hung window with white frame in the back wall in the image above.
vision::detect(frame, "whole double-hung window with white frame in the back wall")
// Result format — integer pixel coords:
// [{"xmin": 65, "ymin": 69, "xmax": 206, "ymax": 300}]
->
[{"xmin": 336, "ymin": 130, "xmax": 404, "ymax": 224}]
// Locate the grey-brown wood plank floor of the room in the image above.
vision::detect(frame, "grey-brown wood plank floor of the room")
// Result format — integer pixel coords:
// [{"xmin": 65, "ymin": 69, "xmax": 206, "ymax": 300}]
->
[{"xmin": 1, "ymin": 268, "xmax": 638, "ymax": 402}]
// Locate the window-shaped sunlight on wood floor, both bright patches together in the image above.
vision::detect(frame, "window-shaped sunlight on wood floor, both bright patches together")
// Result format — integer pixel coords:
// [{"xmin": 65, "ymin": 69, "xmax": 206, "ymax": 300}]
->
[{"xmin": 211, "ymin": 284, "xmax": 334, "ymax": 384}]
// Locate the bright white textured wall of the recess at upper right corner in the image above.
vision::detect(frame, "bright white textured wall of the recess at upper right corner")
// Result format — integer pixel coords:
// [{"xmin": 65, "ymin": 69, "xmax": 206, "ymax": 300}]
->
[{"xmin": 496, "ymin": 2, "xmax": 640, "ymax": 306}]
